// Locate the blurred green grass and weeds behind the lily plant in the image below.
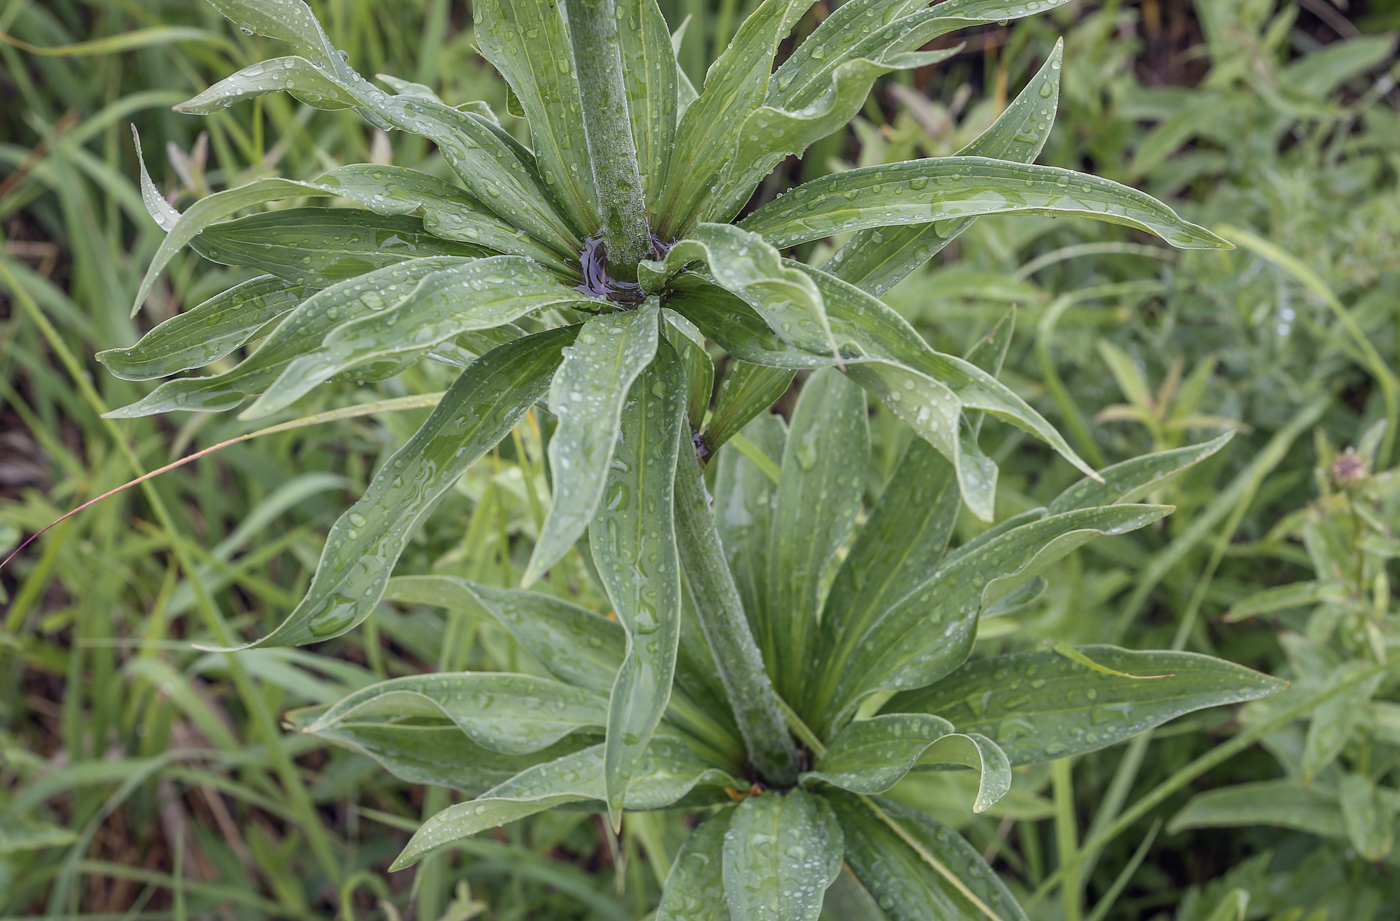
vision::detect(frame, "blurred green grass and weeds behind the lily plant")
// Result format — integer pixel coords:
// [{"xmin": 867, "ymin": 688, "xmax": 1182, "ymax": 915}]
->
[{"xmin": 0, "ymin": 0, "xmax": 1400, "ymax": 921}]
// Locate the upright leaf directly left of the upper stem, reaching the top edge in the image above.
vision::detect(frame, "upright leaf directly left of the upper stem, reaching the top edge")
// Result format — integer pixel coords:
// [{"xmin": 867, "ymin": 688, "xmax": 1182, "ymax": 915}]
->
[{"xmin": 472, "ymin": 0, "xmax": 598, "ymax": 234}]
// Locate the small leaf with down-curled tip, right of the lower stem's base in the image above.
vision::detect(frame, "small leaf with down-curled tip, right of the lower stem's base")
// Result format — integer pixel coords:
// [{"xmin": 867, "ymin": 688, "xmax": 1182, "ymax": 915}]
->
[{"xmin": 802, "ymin": 712, "xmax": 1011, "ymax": 812}]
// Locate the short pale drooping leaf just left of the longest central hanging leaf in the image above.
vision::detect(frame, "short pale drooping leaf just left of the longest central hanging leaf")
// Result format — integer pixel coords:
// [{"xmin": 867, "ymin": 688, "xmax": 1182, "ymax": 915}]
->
[{"xmin": 525, "ymin": 300, "xmax": 661, "ymax": 585}]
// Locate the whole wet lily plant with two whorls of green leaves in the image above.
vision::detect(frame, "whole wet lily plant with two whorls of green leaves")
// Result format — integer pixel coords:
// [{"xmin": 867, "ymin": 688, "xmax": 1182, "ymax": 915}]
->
[{"xmin": 101, "ymin": 0, "xmax": 1280, "ymax": 920}]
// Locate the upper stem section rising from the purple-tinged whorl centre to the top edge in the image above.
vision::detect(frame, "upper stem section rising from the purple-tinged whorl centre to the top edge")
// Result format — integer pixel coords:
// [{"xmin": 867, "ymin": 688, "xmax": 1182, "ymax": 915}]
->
[{"xmin": 564, "ymin": 0, "xmax": 651, "ymax": 275}]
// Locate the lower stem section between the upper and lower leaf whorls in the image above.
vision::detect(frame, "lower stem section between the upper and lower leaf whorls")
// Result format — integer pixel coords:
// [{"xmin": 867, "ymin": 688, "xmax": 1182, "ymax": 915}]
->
[{"xmin": 676, "ymin": 451, "xmax": 801, "ymax": 787}]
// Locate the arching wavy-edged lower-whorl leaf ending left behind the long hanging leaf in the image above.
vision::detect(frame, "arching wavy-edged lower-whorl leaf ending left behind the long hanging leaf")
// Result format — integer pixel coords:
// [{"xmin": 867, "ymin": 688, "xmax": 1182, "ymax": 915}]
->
[{"xmin": 307, "ymin": 672, "xmax": 608, "ymax": 754}]
